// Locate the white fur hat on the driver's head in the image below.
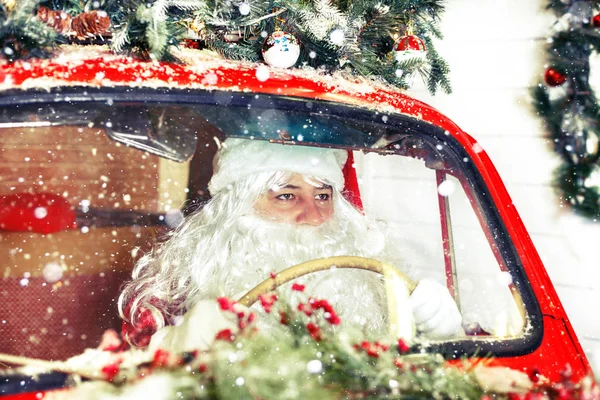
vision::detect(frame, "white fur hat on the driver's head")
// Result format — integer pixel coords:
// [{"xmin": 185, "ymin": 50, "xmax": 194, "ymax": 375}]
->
[{"xmin": 208, "ymin": 138, "xmax": 348, "ymax": 196}]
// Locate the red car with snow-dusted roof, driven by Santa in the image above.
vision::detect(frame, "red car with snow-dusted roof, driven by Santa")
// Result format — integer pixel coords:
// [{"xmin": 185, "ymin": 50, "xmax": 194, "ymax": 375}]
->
[{"xmin": 0, "ymin": 46, "xmax": 591, "ymax": 394}]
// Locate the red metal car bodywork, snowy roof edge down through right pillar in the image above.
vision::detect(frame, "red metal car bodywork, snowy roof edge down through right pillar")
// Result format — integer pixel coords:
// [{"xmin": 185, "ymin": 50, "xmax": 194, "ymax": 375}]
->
[{"xmin": 0, "ymin": 49, "xmax": 591, "ymax": 388}]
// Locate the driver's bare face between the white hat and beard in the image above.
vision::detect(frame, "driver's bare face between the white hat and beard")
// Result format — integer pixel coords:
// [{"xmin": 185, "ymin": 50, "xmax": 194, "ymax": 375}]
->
[{"xmin": 254, "ymin": 174, "xmax": 333, "ymax": 226}]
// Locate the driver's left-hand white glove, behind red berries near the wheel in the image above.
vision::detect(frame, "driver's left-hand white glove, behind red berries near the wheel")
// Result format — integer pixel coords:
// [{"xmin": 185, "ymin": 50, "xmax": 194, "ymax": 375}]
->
[{"xmin": 148, "ymin": 300, "xmax": 242, "ymax": 353}]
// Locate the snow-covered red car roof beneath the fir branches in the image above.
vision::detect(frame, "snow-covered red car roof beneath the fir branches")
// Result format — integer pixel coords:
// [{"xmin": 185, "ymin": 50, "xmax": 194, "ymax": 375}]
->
[{"xmin": 0, "ymin": 45, "xmax": 461, "ymax": 134}]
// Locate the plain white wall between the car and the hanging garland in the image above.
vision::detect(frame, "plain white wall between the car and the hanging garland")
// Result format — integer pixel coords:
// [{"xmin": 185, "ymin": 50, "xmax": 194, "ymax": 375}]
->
[{"xmin": 363, "ymin": 0, "xmax": 600, "ymax": 375}]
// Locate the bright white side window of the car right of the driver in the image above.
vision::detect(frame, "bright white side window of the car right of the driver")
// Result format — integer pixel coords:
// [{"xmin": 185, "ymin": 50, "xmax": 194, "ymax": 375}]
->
[{"xmin": 357, "ymin": 153, "xmax": 525, "ymax": 337}]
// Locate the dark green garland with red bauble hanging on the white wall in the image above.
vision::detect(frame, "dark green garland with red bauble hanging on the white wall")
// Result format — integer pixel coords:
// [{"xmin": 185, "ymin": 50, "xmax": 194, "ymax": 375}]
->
[{"xmin": 533, "ymin": 0, "xmax": 600, "ymax": 222}]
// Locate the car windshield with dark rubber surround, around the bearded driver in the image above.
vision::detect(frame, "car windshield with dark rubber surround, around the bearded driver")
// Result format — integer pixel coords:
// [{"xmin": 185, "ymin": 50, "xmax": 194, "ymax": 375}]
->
[{"xmin": 0, "ymin": 92, "xmax": 541, "ymax": 368}]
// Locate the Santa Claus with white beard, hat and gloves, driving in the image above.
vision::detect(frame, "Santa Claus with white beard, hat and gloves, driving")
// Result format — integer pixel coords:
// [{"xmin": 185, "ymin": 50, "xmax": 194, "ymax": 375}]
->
[{"xmin": 119, "ymin": 138, "xmax": 464, "ymax": 351}]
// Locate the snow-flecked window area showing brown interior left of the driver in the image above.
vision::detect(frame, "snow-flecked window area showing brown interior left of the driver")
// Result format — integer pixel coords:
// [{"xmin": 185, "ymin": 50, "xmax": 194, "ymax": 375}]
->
[{"xmin": 0, "ymin": 125, "xmax": 188, "ymax": 359}]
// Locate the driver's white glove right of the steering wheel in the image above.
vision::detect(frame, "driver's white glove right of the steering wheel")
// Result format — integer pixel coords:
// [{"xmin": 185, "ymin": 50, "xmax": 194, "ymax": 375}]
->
[{"xmin": 408, "ymin": 279, "xmax": 464, "ymax": 339}]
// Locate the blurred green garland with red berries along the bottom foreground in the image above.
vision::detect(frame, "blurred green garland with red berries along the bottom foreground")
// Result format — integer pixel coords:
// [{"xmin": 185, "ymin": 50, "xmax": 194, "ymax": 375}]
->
[{"xmin": 61, "ymin": 290, "xmax": 600, "ymax": 400}]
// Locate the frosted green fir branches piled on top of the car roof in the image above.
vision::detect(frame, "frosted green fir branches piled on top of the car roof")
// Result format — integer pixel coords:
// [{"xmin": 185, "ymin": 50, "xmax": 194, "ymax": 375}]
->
[{"xmin": 0, "ymin": 0, "xmax": 451, "ymax": 93}]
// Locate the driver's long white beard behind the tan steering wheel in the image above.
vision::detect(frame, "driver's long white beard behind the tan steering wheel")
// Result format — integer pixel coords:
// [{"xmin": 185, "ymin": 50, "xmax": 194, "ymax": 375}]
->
[{"xmin": 188, "ymin": 210, "xmax": 398, "ymax": 334}]
